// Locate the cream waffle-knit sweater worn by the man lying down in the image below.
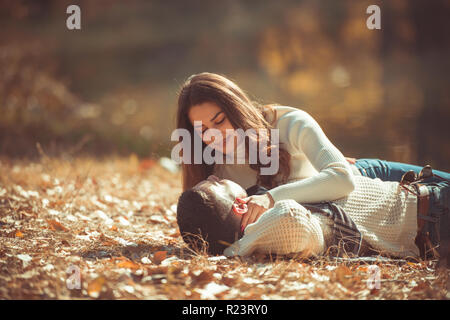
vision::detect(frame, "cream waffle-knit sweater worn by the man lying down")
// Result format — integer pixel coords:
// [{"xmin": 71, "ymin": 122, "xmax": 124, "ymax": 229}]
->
[{"xmin": 224, "ymin": 176, "xmax": 419, "ymax": 257}]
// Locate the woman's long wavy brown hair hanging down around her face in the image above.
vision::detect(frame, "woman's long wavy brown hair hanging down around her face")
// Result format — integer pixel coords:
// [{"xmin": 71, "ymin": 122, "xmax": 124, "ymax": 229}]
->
[{"xmin": 177, "ymin": 72, "xmax": 290, "ymax": 190}]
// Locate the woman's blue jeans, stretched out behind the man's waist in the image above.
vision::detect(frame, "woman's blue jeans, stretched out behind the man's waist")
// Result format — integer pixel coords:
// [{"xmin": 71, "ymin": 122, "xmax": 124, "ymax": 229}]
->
[{"xmin": 355, "ymin": 159, "xmax": 450, "ymax": 183}]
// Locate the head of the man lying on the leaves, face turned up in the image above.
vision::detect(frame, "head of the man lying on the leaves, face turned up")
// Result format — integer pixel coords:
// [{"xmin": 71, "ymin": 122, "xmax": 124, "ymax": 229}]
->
[{"xmin": 177, "ymin": 176, "xmax": 247, "ymax": 254}]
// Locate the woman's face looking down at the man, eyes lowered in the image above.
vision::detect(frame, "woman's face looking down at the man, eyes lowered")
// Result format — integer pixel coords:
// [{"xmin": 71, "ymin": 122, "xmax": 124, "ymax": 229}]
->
[{"xmin": 188, "ymin": 102, "xmax": 236, "ymax": 154}]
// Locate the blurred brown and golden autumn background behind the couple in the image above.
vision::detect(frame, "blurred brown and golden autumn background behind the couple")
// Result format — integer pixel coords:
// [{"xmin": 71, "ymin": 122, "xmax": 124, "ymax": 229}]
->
[{"xmin": 0, "ymin": 0, "xmax": 450, "ymax": 171}]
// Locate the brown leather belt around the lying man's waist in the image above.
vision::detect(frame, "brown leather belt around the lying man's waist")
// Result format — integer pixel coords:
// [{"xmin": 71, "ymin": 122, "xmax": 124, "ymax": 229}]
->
[{"xmin": 415, "ymin": 184, "xmax": 439, "ymax": 259}]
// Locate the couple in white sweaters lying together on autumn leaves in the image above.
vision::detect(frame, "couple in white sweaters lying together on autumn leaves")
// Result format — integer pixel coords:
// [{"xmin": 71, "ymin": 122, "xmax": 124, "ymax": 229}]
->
[{"xmin": 177, "ymin": 72, "xmax": 450, "ymax": 264}]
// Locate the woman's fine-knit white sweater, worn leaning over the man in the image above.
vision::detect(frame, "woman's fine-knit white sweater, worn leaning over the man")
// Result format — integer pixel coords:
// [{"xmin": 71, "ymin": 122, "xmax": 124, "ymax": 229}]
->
[{"xmin": 214, "ymin": 106, "xmax": 358, "ymax": 203}]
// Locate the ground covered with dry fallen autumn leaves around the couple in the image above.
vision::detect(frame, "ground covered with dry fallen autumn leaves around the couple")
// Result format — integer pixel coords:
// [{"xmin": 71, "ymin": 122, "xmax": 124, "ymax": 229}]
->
[{"xmin": 0, "ymin": 156, "xmax": 449, "ymax": 299}]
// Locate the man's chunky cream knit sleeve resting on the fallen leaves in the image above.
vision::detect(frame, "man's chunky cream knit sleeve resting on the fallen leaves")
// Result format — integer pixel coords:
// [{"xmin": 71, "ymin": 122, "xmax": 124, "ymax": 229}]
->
[{"xmin": 224, "ymin": 200, "xmax": 325, "ymax": 257}]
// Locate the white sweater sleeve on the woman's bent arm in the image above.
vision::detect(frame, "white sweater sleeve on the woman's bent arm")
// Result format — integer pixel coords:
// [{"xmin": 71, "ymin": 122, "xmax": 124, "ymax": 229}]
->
[{"xmin": 269, "ymin": 110, "xmax": 355, "ymax": 203}]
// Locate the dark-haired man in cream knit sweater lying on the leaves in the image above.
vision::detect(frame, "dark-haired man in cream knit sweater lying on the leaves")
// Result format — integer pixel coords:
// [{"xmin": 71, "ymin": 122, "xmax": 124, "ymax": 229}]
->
[{"xmin": 177, "ymin": 171, "xmax": 450, "ymax": 261}]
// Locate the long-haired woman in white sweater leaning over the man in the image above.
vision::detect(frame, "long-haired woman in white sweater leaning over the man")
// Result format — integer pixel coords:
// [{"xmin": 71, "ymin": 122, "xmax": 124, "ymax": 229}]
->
[{"xmin": 177, "ymin": 72, "xmax": 445, "ymax": 229}]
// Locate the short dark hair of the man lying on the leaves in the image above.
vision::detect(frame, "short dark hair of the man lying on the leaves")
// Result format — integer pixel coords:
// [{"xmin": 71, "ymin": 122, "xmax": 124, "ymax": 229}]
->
[{"xmin": 177, "ymin": 189, "xmax": 240, "ymax": 254}]
